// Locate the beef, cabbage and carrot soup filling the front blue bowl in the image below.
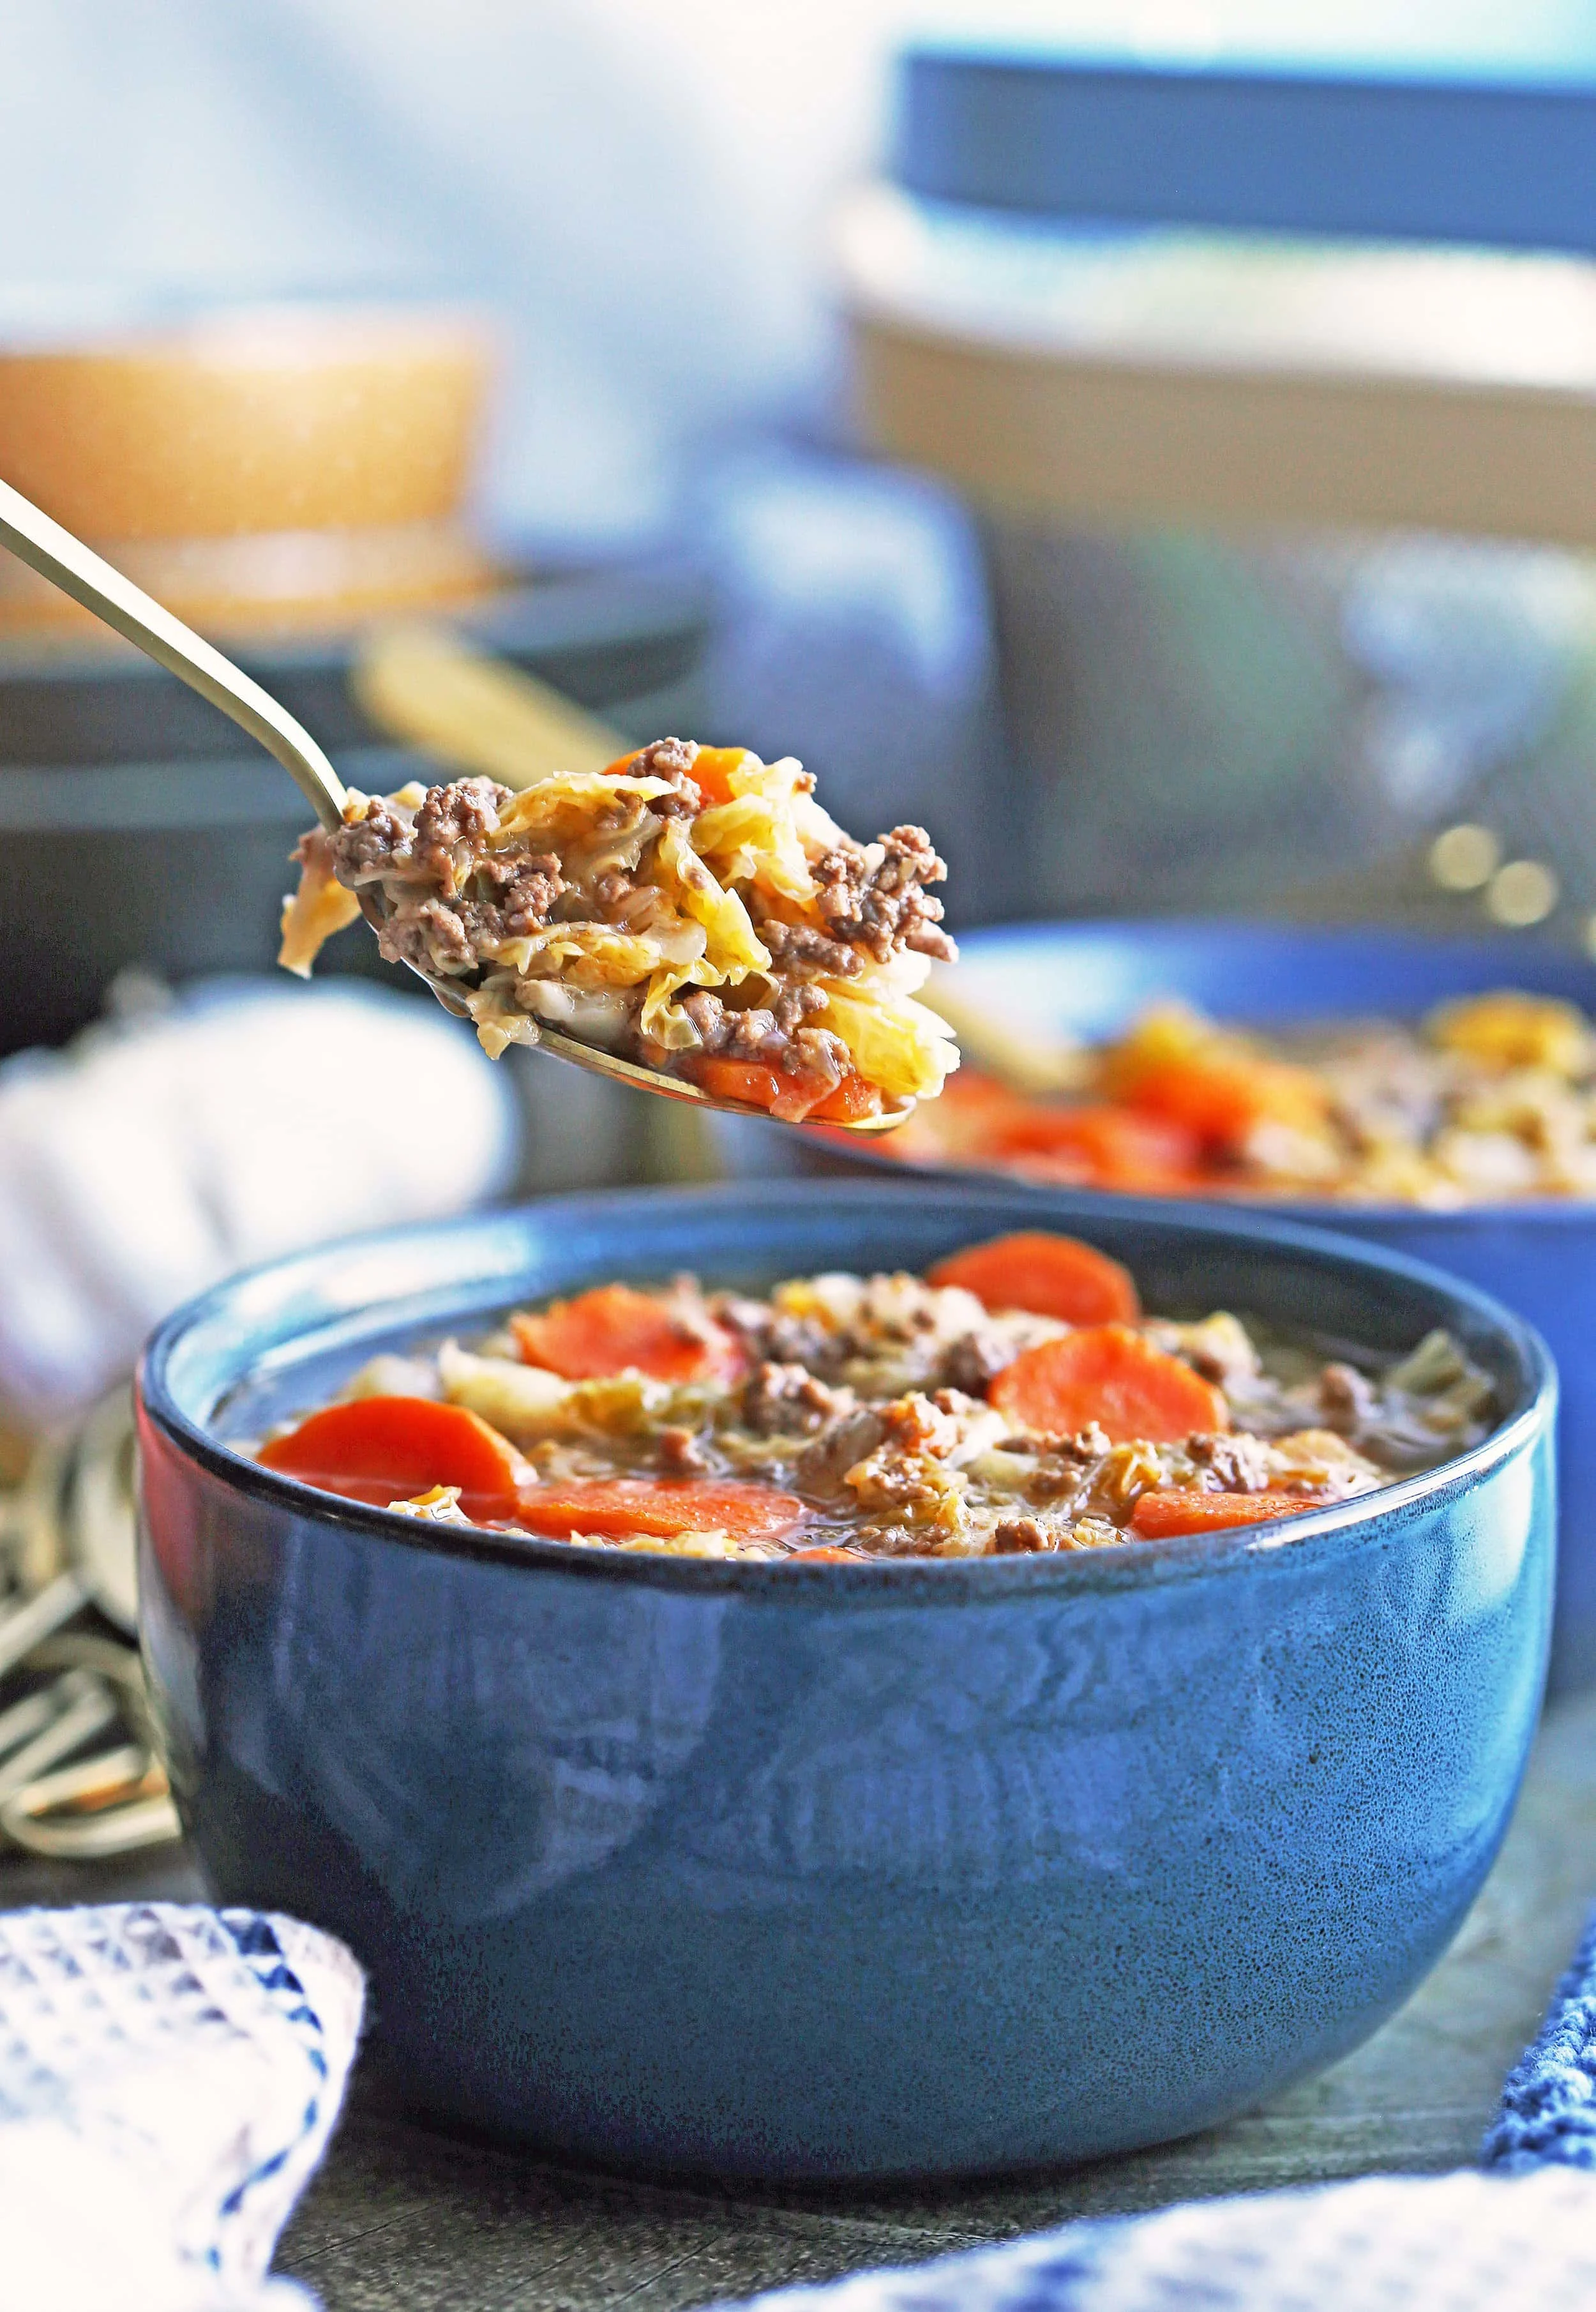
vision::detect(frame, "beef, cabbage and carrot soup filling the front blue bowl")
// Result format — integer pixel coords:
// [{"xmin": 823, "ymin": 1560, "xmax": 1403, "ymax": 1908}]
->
[{"xmin": 255, "ymin": 1232, "xmax": 1492, "ymax": 1559}]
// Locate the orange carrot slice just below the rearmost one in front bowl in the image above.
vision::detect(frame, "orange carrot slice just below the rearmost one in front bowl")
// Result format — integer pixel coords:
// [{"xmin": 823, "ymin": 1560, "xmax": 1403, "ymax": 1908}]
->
[{"xmin": 988, "ymin": 1325, "xmax": 1231, "ymax": 1445}]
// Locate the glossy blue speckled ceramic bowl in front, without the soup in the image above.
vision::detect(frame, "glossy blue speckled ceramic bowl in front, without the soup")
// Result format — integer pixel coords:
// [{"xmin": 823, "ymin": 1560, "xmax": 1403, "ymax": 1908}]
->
[{"xmin": 141, "ymin": 1184, "xmax": 1555, "ymax": 2178}]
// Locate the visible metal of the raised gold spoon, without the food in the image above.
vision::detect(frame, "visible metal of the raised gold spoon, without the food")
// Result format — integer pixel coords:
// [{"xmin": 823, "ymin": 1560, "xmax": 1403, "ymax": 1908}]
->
[{"xmin": 0, "ymin": 481, "xmax": 914, "ymax": 1133}]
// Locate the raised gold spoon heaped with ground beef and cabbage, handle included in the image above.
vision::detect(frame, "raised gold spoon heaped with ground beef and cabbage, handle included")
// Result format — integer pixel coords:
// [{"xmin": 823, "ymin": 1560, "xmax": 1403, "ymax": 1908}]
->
[{"xmin": 0, "ymin": 483, "xmax": 958, "ymax": 1133}]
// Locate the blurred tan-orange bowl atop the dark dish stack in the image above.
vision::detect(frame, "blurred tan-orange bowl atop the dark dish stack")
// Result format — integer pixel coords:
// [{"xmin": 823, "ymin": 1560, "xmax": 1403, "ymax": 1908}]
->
[{"xmin": 0, "ymin": 308, "xmax": 497, "ymax": 638}]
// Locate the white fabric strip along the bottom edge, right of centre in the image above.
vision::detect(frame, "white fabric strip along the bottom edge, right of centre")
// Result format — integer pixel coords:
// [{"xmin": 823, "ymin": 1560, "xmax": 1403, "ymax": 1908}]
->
[{"xmin": 730, "ymin": 2166, "xmax": 1596, "ymax": 2312}]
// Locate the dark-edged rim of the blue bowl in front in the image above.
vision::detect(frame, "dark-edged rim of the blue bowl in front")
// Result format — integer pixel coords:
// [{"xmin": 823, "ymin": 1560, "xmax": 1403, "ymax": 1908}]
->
[{"xmin": 134, "ymin": 1181, "xmax": 1556, "ymax": 1602}]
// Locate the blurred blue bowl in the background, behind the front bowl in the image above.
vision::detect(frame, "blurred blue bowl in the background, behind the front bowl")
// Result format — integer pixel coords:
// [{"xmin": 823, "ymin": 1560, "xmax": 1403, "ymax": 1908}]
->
[{"xmin": 719, "ymin": 923, "xmax": 1596, "ymax": 1690}]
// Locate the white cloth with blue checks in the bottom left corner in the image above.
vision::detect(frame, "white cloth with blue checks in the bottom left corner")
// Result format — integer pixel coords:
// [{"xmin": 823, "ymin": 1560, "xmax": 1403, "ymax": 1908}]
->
[{"xmin": 0, "ymin": 1903, "xmax": 363, "ymax": 2312}]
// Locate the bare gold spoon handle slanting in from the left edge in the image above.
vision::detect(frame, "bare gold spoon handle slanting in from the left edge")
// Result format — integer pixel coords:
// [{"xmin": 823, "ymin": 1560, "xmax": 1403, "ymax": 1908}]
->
[{"xmin": 0, "ymin": 481, "xmax": 345, "ymax": 827}]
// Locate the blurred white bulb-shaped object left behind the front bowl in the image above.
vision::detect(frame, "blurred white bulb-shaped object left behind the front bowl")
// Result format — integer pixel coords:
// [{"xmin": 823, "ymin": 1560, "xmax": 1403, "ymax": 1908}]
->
[{"xmin": 0, "ymin": 980, "xmax": 518, "ymax": 1424}]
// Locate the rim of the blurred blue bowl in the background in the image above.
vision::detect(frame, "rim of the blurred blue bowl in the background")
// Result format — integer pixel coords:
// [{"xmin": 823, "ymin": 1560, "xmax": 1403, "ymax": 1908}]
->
[{"xmin": 855, "ymin": 916, "xmax": 1596, "ymax": 1230}]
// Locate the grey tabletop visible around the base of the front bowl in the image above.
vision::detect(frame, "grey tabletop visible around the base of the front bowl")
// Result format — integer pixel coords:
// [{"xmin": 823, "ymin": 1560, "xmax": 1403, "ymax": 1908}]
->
[{"xmin": 0, "ymin": 1697, "xmax": 1596, "ymax": 2312}]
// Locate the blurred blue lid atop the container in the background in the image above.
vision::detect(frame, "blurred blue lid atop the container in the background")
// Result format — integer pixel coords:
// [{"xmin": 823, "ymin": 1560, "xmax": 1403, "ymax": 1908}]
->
[{"xmin": 893, "ymin": 49, "xmax": 1596, "ymax": 250}]
